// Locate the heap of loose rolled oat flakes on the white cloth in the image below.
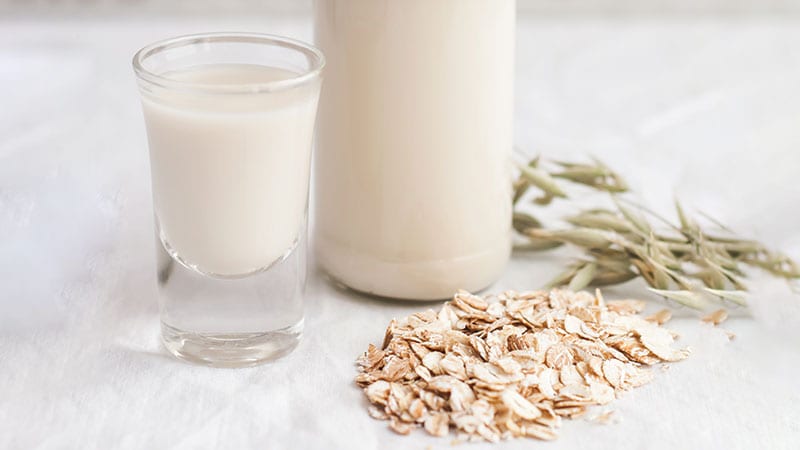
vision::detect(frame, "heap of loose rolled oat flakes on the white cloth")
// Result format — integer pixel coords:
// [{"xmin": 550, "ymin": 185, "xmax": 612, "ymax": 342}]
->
[{"xmin": 356, "ymin": 291, "xmax": 689, "ymax": 442}]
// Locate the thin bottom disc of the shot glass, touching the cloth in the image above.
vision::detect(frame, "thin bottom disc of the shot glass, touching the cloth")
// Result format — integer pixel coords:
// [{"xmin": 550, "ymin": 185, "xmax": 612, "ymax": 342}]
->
[{"xmin": 161, "ymin": 320, "xmax": 303, "ymax": 368}]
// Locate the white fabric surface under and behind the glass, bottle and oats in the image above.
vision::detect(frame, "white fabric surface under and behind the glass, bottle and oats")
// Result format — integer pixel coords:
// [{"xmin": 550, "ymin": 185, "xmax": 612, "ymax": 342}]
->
[{"xmin": 0, "ymin": 17, "xmax": 800, "ymax": 450}]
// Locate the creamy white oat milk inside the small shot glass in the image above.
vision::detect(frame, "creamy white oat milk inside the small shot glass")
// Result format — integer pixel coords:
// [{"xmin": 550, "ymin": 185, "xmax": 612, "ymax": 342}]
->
[{"xmin": 143, "ymin": 64, "xmax": 319, "ymax": 276}]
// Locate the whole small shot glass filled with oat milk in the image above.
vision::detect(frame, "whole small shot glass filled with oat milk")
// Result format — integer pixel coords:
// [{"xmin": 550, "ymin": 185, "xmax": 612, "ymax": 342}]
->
[{"xmin": 133, "ymin": 33, "xmax": 325, "ymax": 367}]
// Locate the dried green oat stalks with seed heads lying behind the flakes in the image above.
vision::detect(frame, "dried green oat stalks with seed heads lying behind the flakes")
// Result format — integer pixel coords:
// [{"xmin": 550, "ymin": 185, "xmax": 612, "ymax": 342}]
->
[{"xmin": 514, "ymin": 158, "xmax": 800, "ymax": 309}]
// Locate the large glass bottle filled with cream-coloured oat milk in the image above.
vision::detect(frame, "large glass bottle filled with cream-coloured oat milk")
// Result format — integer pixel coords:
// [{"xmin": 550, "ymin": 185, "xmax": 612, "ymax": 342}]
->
[{"xmin": 315, "ymin": 0, "xmax": 516, "ymax": 299}]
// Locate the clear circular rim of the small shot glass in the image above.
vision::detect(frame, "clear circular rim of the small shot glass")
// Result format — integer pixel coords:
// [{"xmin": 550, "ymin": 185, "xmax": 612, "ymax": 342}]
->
[{"xmin": 132, "ymin": 32, "xmax": 325, "ymax": 94}]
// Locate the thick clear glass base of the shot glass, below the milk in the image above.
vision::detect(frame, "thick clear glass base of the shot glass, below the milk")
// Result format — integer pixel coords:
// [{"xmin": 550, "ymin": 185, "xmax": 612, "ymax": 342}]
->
[{"xmin": 157, "ymin": 225, "xmax": 306, "ymax": 367}]
